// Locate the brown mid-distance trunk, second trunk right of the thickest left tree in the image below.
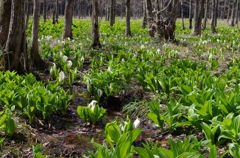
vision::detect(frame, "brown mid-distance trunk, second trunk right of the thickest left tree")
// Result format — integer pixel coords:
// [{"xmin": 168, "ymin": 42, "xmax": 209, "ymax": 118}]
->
[{"xmin": 63, "ymin": 0, "xmax": 73, "ymax": 39}]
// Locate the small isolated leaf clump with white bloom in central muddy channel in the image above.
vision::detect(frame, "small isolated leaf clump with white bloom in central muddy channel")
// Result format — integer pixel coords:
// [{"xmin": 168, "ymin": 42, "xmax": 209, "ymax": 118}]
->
[{"xmin": 77, "ymin": 100, "xmax": 107, "ymax": 124}]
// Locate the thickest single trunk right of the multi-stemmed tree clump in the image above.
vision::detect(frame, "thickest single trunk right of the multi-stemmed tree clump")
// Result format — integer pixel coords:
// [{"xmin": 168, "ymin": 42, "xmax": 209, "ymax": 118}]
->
[{"xmin": 193, "ymin": 0, "xmax": 204, "ymax": 35}]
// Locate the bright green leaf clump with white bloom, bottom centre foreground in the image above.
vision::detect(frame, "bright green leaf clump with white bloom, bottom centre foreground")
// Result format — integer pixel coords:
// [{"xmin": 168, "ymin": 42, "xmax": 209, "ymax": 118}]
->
[{"xmin": 85, "ymin": 118, "xmax": 141, "ymax": 158}]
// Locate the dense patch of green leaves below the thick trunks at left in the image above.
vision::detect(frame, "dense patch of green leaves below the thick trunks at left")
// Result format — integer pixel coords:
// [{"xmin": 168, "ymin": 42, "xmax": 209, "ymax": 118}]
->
[{"xmin": 0, "ymin": 71, "xmax": 71, "ymax": 121}]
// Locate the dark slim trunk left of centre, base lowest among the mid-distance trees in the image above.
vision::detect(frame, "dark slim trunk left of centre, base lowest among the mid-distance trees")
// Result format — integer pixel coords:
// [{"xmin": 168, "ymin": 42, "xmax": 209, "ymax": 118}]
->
[{"xmin": 92, "ymin": 0, "xmax": 101, "ymax": 48}]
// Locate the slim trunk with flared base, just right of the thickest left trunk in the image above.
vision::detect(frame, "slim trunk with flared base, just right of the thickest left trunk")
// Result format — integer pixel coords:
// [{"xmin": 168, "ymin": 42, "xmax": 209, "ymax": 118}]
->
[{"xmin": 31, "ymin": 0, "xmax": 45, "ymax": 70}]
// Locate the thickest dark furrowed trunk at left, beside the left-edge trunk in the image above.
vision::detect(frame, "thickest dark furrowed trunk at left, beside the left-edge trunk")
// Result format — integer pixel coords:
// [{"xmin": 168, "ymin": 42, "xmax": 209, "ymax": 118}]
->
[{"xmin": 4, "ymin": 0, "xmax": 27, "ymax": 73}]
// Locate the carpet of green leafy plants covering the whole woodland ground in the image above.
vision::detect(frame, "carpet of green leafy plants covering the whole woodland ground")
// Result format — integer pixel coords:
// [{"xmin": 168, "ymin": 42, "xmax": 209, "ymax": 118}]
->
[{"xmin": 0, "ymin": 20, "xmax": 240, "ymax": 158}]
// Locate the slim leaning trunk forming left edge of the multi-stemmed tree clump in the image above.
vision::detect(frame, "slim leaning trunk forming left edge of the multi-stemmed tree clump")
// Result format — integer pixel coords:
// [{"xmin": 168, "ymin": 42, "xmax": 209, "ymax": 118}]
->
[{"xmin": 146, "ymin": 0, "xmax": 156, "ymax": 37}]
